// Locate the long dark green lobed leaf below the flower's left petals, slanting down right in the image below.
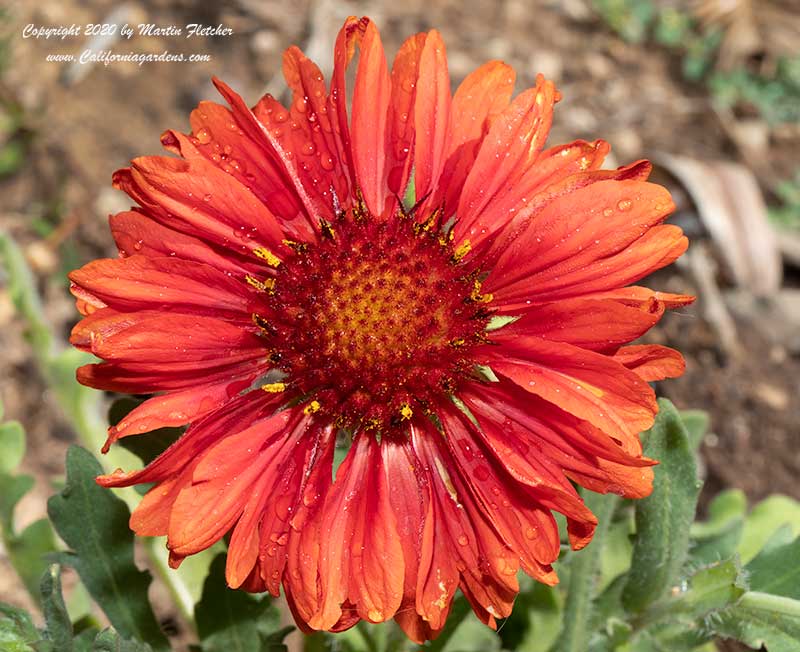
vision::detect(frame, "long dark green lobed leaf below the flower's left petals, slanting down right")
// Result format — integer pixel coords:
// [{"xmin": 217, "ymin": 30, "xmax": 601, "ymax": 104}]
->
[{"xmin": 47, "ymin": 446, "xmax": 169, "ymax": 650}]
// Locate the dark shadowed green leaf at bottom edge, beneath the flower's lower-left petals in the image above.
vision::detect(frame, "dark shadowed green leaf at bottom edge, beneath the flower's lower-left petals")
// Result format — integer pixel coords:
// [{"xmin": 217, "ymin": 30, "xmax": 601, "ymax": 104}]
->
[{"xmin": 195, "ymin": 555, "xmax": 282, "ymax": 652}]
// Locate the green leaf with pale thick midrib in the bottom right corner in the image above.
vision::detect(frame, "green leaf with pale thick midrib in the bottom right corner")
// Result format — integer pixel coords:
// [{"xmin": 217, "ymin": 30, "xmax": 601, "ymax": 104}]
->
[{"xmin": 712, "ymin": 591, "xmax": 800, "ymax": 652}]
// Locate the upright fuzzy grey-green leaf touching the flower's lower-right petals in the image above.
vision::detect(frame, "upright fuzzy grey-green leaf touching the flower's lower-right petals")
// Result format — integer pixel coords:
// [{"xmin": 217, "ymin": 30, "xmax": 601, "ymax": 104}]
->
[{"xmin": 622, "ymin": 399, "xmax": 700, "ymax": 613}]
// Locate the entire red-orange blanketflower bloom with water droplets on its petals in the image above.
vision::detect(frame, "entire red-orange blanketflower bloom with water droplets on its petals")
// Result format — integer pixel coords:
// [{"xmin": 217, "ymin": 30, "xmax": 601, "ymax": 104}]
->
[{"xmin": 70, "ymin": 18, "xmax": 691, "ymax": 641}]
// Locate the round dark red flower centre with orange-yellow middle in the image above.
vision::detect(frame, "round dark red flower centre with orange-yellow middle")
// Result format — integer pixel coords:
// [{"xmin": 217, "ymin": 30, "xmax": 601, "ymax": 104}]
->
[{"xmin": 270, "ymin": 219, "xmax": 487, "ymax": 430}]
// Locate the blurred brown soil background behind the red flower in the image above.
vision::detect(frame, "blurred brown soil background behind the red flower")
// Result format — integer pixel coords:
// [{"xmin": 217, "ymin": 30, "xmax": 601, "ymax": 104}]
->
[{"xmin": 0, "ymin": 0, "xmax": 800, "ymax": 648}]
